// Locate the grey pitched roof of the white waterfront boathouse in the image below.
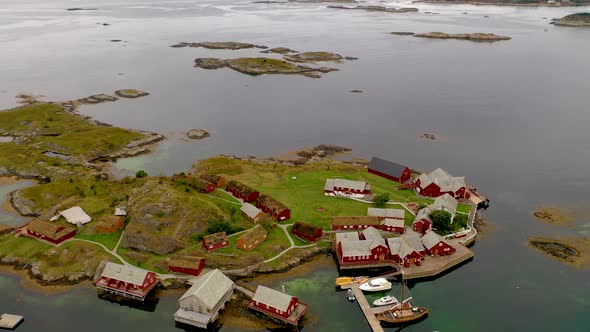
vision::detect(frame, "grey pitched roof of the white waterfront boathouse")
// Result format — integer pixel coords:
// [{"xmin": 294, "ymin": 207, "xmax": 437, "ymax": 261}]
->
[{"xmin": 179, "ymin": 269, "xmax": 234, "ymax": 308}]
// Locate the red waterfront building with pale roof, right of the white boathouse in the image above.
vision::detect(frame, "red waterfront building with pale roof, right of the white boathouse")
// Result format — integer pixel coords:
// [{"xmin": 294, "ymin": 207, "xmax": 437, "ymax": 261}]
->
[{"xmin": 248, "ymin": 286, "xmax": 308, "ymax": 325}]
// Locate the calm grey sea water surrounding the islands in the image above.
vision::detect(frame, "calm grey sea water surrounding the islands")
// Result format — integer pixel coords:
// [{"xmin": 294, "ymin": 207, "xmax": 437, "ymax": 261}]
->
[{"xmin": 0, "ymin": 0, "xmax": 590, "ymax": 332}]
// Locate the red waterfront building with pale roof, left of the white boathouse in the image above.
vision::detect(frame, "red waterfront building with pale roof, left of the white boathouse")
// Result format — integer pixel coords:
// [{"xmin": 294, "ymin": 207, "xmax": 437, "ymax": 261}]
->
[{"xmin": 96, "ymin": 262, "xmax": 158, "ymax": 301}]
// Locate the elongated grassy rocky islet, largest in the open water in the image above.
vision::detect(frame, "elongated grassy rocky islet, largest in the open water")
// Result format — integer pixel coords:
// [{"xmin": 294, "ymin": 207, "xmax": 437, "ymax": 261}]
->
[{"xmin": 194, "ymin": 58, "xmax": 338, "ymax": 78}]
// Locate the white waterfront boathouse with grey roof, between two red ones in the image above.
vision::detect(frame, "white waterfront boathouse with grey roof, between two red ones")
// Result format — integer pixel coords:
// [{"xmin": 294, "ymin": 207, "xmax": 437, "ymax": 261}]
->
[{"xmin": 174, "ymin": 270, "xmax": 235, "ymax": 328}]
